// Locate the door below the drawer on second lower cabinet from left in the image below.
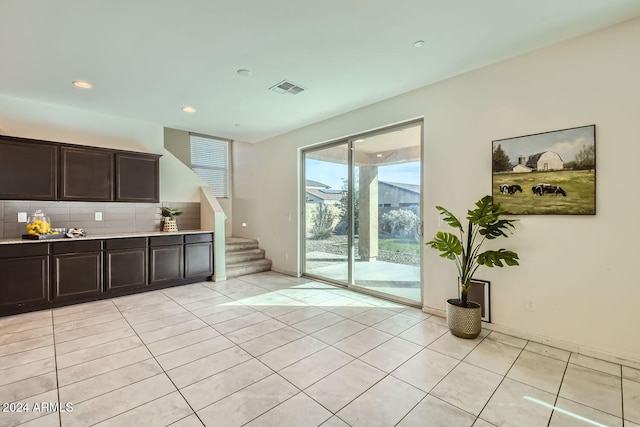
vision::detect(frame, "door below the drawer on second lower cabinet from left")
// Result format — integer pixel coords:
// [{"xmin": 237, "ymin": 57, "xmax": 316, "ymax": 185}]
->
[{"xmin": 53, "ymin": 252, "xmax": 102, "ymax": 300}]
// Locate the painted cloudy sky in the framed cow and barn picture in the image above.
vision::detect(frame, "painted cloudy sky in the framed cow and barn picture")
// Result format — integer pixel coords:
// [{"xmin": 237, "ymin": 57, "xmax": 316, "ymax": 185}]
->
[{"xmin": 493, "ymin": 126, "xmax": 595, "ymax": 164}]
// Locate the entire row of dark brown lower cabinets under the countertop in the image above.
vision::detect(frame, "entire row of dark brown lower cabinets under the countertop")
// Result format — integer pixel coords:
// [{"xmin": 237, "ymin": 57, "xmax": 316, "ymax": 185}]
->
[{"xmin": 0, "ymin": 232, "xmax": 214, "ymax": 315}]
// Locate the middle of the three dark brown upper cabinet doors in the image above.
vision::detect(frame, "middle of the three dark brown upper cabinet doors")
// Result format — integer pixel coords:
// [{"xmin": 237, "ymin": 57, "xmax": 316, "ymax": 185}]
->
[{"xmin": 60, "ymin": 147, "xmax": 113, "ymax": 201}]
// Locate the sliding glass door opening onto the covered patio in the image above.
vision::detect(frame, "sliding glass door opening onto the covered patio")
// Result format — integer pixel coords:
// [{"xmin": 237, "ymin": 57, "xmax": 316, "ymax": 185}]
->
[{"xmin": 303, "ymin": 122, "xmax": 423, "ymax": 305}]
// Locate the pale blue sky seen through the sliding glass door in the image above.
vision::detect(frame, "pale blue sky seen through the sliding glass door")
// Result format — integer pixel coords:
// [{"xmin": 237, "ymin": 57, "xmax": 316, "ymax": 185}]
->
[{"xmin": 305, "ymin": 159, "xmax": 420, "ymax": 190}]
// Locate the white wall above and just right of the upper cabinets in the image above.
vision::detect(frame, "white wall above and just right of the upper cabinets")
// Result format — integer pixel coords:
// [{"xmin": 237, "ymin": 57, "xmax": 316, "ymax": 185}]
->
[{"xmin": 0, "ymin": 95, "xmax": 203, "ymax": 202}]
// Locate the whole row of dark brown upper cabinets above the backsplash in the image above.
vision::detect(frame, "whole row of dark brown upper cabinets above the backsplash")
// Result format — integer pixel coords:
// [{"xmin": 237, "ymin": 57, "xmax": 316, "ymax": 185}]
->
[{"xmin": 0, "ymin": 135, "xmax": 161, "ymax": 203}]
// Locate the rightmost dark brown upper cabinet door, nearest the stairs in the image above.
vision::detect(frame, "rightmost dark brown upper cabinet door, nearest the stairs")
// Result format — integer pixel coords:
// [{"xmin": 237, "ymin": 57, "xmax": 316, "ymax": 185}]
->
[{"xmin": 116, "ymin": 153, "xmax": 160, "ymax": 203}]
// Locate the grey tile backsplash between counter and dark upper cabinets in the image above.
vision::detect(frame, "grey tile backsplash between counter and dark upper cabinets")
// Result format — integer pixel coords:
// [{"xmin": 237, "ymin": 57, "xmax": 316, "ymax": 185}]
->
[{"xmin": 0, "ymin": 200, "xmax": 200, "ymax": 239}]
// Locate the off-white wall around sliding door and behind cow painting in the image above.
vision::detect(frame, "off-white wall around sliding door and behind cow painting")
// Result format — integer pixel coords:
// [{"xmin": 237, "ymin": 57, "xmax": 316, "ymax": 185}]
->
[{"xmin": 234, "ymin": 19, "xmax": 640, "ymax": 360}]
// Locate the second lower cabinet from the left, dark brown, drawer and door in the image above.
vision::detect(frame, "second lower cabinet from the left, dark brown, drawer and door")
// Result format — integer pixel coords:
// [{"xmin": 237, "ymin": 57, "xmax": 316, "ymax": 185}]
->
[{"xmin": 52, "ymin": 240, "xmax": 102, "ymax": 301}]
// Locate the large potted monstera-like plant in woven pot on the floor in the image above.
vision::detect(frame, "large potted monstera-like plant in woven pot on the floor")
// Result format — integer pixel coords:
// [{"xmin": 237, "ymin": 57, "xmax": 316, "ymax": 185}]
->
[{"xmin": 426, "ymin": 196, "xmax": 519, "ymax": 338}]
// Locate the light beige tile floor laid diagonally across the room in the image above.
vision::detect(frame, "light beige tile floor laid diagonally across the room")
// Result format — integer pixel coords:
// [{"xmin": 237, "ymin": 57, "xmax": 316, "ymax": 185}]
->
[{"xmin": 0, "ymin": 272, "xmax": 640, "ymax": 427}]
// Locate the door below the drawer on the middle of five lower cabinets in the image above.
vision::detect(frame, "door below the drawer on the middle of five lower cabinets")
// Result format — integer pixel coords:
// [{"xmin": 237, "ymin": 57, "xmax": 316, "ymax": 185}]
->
[{"xmin": 105, "ymin": 248, "xmax": 147, "ymax": 290}]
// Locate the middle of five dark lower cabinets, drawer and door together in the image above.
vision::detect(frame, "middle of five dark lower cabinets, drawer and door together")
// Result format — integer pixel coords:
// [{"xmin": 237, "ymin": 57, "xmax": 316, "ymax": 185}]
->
[{"xmin": 104, "ymin": 237, "xmax": 148, "ymax": 291}]
